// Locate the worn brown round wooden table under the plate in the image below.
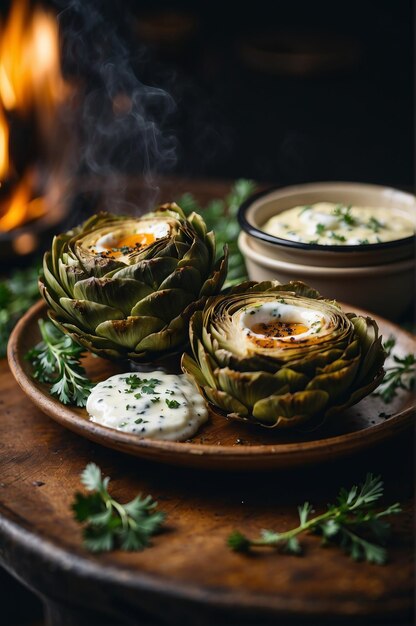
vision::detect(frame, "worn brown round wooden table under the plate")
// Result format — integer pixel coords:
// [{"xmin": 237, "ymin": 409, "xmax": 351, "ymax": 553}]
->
[{"xmin": 0, "ymin": 177, "xmax": 414, "ymax": 626}]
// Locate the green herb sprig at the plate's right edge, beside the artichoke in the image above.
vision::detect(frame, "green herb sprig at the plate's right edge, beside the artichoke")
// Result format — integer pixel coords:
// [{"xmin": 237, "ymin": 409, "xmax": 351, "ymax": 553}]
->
[{"xmin": 374, "ymin": 336, "xmax": 416, "ymax": 404}]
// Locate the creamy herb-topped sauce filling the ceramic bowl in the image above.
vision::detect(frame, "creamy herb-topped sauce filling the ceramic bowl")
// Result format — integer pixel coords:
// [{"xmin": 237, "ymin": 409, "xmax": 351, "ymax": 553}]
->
[{"xmin": 262, "ymin": 202, "xmax": 416, "ymax": 246}]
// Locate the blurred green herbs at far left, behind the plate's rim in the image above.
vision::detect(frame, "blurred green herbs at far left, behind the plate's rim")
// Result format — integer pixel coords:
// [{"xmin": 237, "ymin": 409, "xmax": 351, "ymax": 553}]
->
[{"xmin": 0, "ymin": 267, "xmax": 39, "ymax": 358}]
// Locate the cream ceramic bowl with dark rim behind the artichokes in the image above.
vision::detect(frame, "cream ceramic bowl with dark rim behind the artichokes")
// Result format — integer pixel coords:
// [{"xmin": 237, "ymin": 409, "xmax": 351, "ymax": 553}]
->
[{"xmin": 238, "ymin": 182, "xmax": 416, "ymax": 320}]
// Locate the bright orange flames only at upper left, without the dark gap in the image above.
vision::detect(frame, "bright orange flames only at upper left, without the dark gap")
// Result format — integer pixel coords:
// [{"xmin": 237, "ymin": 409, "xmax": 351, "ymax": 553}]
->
[{"xmin": 0, "ymin": 0, "xmax": 68, "ymax": 232}]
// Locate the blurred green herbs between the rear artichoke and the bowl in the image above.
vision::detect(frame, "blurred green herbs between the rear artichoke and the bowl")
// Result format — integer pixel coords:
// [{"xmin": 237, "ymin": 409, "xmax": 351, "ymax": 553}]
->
[{"xmin": 178, "ymin": 179, "xmax": 255, "ymax": 288}]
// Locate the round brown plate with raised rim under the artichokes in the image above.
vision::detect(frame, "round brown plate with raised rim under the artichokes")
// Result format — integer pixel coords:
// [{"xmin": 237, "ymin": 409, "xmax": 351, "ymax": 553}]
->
[{"xmin": 8, "ymin": 302, "xmax": 416, "ymax": 470}]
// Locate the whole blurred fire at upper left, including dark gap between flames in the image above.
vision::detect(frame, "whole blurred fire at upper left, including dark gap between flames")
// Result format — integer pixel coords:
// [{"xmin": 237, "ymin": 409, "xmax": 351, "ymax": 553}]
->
[{"xmin": 0, "ymin": 0, "xmax": 71, "ymax": 255}]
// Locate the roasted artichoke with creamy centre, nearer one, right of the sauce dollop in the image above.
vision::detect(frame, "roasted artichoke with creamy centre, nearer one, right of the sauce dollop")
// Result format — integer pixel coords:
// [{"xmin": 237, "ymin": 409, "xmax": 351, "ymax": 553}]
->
[{"xmin": 182, "ymin": 282, "xmax": 386, "ymax": 428}]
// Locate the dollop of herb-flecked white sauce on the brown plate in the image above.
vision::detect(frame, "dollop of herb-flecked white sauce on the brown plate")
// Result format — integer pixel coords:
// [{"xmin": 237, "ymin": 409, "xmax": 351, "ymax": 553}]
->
[{"xmin": 87, "ymin": 371, "xmax": 208, "ymax": 441}]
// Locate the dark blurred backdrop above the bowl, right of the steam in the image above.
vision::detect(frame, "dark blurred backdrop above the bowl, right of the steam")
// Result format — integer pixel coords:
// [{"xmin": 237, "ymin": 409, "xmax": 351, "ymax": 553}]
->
[{"xmin": 0, "ymin": 0, "xmax": 415, "ymax": 626}]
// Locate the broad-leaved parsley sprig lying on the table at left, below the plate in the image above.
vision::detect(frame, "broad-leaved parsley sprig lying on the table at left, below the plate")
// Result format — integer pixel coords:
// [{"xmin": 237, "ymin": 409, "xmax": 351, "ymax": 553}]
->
[{"xmin": 72, "ymin": 463, "xmax": 165, "ymax": 552}]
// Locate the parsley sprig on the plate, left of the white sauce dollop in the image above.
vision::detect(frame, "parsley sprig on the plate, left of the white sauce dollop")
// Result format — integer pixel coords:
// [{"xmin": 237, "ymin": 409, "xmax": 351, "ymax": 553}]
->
[{"xmin": 25, "ymin": 320, "xmax": 93, "ymax": 407}]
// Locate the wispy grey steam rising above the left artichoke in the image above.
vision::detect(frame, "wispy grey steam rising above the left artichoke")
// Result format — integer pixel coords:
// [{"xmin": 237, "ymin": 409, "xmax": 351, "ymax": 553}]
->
[{"xmin": 58, "ymin": 0, "xmax": 177, "ymax": 208}]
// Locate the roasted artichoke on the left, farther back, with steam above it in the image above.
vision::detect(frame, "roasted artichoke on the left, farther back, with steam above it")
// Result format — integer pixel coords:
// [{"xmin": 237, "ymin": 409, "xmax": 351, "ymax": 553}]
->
[{"xmin": 40, "ymin": 204, "xmax": 227, "ymax": 362}]
